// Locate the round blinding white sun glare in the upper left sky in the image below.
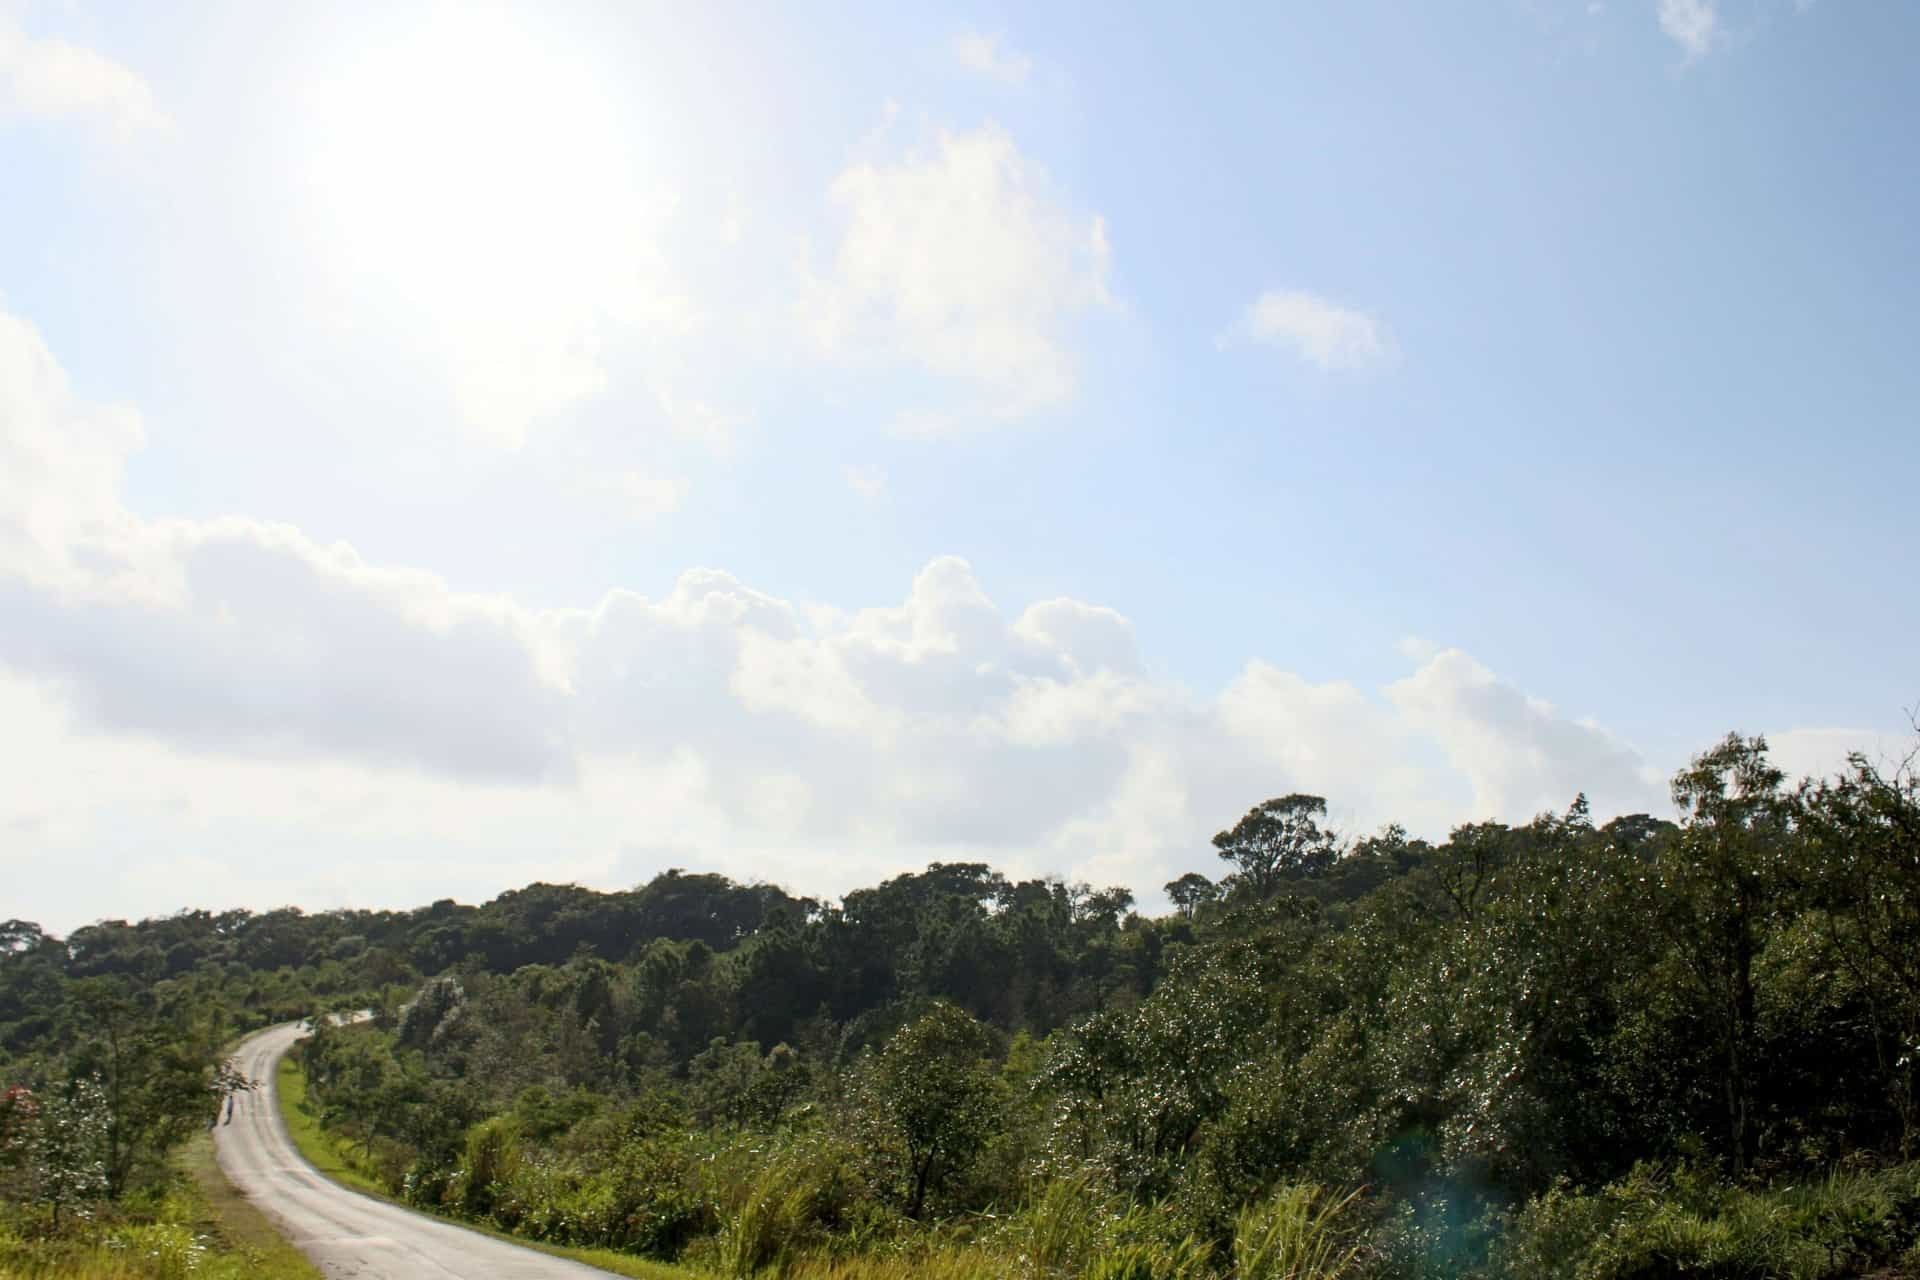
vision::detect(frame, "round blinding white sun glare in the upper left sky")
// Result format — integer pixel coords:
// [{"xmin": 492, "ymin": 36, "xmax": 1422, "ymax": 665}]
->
[{"xmin": 303, "ymin": 8, "xmax": 645, "ymax": 408}]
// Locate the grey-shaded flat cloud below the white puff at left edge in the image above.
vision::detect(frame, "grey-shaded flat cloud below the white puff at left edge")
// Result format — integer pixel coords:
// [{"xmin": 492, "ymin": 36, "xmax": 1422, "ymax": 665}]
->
[{"xmin": 0, "ymin": 518, "xmax": 572, "ymax": 783}]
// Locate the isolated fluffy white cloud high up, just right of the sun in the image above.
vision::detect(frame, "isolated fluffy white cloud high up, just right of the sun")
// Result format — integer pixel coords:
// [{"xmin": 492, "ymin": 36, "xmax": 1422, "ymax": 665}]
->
[{"xmin": 801, "ymin": 125, "xmax": 1112, "ymax": 432}]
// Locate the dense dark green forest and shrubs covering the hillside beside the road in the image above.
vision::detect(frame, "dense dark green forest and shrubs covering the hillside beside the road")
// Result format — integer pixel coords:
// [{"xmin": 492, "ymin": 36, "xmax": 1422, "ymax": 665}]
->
[{"xmin": 11, "ymin": 737, "xmax": 1920, "ymax": 1280}]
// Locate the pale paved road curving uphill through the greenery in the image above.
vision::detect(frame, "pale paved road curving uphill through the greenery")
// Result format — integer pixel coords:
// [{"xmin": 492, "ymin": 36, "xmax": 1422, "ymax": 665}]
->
[{"xmin": 213, "ymin": 1023, "xmax": 609, "ymax": 1280}]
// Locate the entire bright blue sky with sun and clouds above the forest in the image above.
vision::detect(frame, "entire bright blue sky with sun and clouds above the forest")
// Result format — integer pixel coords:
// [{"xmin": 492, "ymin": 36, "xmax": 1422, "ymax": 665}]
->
[{"xmin": 0, "ymin": 0, "xmax": 1920, "ymax": 933}]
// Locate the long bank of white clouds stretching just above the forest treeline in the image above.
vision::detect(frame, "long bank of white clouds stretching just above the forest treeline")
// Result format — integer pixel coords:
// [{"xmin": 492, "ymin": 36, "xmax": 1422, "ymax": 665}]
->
[{"xmin": 15, "ymin": 301, "xmax": 1881, "ymax": 927}]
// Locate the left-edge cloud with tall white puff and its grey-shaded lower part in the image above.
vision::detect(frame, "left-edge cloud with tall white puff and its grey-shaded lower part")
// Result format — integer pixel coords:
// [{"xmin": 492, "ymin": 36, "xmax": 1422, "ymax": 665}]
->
[{"xmin": 0, "ymin": 313, "xmax": 572, "ymax": 781}]
